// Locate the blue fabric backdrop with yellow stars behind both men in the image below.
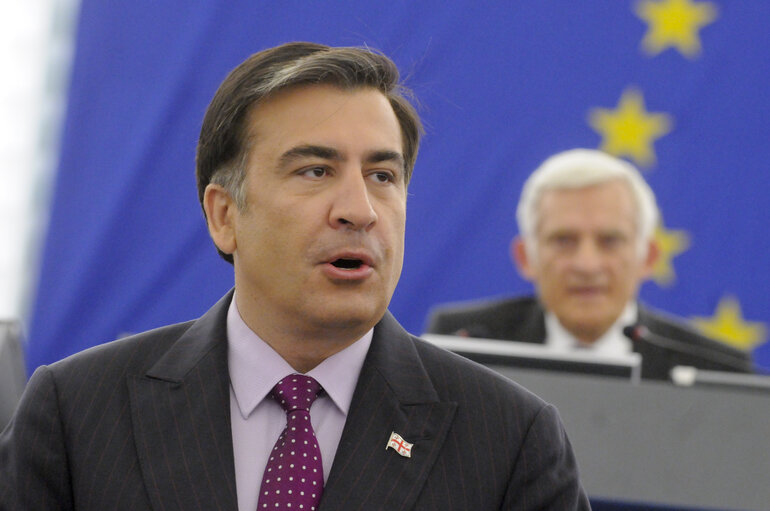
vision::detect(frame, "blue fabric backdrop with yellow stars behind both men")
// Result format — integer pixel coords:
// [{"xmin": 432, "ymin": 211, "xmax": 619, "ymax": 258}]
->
[{"xmin": 28, "ymin": 0, "xmax": 770, "ymax": 369}]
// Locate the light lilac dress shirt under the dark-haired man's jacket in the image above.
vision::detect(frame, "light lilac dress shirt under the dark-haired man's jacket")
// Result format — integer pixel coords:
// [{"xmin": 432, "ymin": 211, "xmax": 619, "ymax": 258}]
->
[{"xmin": 227, "ymin": 296, "xmax": 372, "ymax": 511}]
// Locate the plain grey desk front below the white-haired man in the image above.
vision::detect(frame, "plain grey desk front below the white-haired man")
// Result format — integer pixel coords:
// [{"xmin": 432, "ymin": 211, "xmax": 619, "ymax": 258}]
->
[{"xmin": 493, "ymin": 366, "xmax": 770, "ymax": 510}]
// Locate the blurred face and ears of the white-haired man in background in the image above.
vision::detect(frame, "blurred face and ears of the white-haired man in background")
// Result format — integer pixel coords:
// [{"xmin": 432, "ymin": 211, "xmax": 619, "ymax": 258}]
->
[{"xmin": 514, "ymin": 181, "xmax": 654, "ymax": 342}]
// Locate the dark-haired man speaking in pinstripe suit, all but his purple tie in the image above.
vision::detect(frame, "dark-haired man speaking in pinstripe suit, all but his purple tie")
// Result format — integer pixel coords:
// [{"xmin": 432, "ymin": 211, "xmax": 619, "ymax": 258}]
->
[{"xmin": 0, "ymin": 43, "xmax": 589, "ymax": 511}]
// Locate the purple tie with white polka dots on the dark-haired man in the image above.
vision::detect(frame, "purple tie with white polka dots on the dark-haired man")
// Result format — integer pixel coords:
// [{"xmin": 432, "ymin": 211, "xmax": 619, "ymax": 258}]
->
[{"xmin": 257, "ymin": 374, "xmax": 324, "ymax": 511}]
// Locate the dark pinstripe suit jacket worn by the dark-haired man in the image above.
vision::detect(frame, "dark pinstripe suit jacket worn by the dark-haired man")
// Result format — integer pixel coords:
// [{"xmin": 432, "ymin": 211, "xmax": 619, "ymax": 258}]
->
[{"xmin": 0, "ymin": 295, "xmax": 589, "ymax": 511}]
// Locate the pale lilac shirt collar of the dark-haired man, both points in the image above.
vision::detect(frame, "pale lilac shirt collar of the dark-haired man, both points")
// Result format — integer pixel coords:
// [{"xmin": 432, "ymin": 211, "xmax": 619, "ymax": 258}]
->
[{"xmin": 227, "ymin": 295, "xmax": 373, "ymax": 419}]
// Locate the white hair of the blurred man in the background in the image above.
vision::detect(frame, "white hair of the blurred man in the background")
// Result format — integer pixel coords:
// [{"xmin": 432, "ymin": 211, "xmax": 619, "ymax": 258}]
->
[{"xmin": 516, "ymin": 149, "xmax": 659, "ymax": 257}]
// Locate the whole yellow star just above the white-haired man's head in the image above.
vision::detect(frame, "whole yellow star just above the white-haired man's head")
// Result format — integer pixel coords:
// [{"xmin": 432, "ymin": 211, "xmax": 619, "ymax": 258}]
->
[{"xmin": 588, "ymin": 88, "xmax": 673, "ymax": 167}]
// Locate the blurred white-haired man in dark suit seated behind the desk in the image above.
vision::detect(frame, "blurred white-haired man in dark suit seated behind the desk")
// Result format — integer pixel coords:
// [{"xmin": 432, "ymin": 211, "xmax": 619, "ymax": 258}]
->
[{"xmin": 427, "ymin": 149, "xmax": 751, "ymax": 379}]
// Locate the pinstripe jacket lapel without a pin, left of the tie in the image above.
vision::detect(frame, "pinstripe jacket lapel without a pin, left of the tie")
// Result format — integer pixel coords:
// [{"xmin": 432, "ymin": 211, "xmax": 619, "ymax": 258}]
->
[{"xmin": 128, "ymin": 292, "xmax": 237, "ymax": 511}]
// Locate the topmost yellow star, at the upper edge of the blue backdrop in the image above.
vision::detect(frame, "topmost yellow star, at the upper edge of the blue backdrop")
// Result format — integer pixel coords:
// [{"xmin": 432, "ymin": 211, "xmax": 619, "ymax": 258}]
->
[{"xmin": 635, "ymin": 0, "xmax": 717, "ymax": 59}]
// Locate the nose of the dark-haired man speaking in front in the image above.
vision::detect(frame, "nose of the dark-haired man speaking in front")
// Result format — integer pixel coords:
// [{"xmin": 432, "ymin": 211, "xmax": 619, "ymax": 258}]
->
[{"xmin": 329, "ymin": 172, "xmax": 377, "ymax": 230}]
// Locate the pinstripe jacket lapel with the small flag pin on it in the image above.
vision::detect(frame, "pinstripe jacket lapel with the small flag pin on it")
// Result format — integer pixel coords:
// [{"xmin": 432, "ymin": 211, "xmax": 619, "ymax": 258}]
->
[{"xmin": 320, "ymin": 313, "xmax": 457, "ymax": 511}]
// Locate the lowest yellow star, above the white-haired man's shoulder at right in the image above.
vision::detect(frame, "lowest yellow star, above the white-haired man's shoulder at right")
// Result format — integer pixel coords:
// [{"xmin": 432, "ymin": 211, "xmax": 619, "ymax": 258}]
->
[{"xmin": 693, "ymin": 296, "xmax": 767, "ymax": 350}]
